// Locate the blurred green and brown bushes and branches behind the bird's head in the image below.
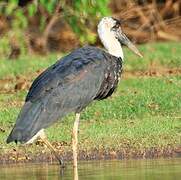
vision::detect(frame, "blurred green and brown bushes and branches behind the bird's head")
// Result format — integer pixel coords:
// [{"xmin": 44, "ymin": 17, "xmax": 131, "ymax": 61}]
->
[{"xmin": 0, "ymin": 0, "xmax": 181, "ymax": 59}]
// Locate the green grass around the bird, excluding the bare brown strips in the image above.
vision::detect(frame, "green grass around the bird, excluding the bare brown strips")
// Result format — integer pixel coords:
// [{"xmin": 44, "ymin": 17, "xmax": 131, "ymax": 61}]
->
[{"xmin": 0, "ymin": 43, "xmax": 181, "ymax": 156}]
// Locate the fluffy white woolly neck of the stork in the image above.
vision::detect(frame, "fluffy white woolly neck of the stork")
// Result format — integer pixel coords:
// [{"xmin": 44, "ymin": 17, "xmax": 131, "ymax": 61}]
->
[{"xmin": 98, "ymin": 21, "xmax": 124, "ymax": 60}]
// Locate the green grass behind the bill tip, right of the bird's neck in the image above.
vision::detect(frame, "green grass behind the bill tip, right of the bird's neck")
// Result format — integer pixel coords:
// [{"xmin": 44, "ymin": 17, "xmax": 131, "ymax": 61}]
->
[{"xmin": 125, "ymin": 42, "xmax": 181, "ymax": 70}]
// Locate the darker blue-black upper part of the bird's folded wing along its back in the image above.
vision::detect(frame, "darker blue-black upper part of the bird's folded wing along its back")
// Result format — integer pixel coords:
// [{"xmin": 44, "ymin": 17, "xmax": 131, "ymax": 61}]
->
[{"xmin": 25, "ymin": 46, "xmax": 104, "ymax": 102}]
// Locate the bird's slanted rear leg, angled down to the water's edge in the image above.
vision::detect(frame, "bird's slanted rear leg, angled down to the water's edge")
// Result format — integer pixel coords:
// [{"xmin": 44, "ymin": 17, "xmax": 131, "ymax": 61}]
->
[{"xmin": 39, "ymin": 133, "xmax": 65, "ymax": 168}]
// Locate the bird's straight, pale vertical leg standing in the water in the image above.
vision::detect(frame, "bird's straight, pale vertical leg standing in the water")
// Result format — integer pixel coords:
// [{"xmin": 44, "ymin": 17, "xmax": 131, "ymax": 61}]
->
[{"xmin": 72, "ymin": 113, "xmax": 80, "ymax": 168}]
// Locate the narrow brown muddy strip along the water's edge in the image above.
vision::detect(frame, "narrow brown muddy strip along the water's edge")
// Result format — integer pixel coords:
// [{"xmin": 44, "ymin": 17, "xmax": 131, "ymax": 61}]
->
[{"xmin": 0, "ymin": 146, "xmax": 181, "ymax": 164}]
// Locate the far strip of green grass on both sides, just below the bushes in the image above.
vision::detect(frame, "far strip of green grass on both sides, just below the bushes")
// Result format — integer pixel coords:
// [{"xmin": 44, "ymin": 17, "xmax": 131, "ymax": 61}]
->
[{"xmin": 0, "ymin": 42, "xmax": 181, "ymax": 79}]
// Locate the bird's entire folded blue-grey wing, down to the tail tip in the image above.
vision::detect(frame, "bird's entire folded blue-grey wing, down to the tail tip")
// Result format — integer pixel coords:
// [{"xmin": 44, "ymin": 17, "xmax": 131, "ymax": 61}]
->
[{"xmin": 7, "ymin": 47, "xmax": 107, "ymax": 142}]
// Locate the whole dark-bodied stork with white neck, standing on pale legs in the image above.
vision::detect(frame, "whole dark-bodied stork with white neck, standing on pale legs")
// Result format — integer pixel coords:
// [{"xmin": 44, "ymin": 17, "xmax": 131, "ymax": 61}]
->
[{"xmin": 7, "ymin": 17, "xmax": 141, "ymax": 166}]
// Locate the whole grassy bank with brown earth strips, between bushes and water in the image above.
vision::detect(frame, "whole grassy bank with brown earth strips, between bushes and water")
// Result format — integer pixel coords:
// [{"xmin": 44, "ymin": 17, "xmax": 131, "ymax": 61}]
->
[{"xmin": 0, "ymin": 43, "xmax": 181, "ymax": 164}]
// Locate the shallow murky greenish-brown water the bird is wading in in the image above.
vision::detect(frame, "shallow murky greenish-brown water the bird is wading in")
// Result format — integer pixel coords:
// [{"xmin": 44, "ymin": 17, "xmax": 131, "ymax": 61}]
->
[{"xmin": 0, "ymin": 158, "xmax": 181, "ymax": 180}]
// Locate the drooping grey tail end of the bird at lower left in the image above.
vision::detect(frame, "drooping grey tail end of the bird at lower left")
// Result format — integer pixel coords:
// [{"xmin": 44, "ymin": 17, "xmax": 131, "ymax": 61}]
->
[{"xmin": 6, "ymin": 101, "xmax": 42, "ymax": 143}]
